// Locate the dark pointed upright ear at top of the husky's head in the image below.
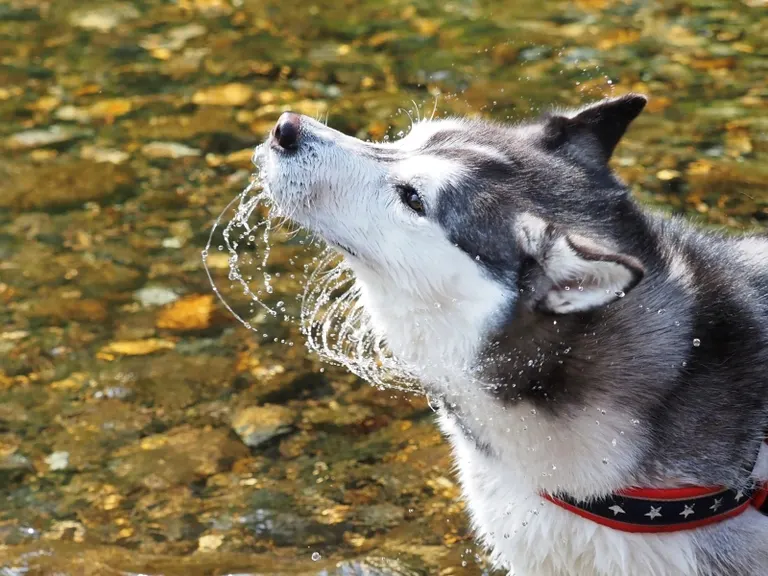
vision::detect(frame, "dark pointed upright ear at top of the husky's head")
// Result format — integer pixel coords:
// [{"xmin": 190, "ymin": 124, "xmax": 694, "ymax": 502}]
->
[{"xmin": 544, "ymin": 93, "xmax": 648, "ymax": 161}]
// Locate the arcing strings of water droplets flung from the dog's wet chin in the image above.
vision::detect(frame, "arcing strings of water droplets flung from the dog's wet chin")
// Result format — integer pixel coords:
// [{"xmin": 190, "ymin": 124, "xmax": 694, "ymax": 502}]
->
[{"xmin": 202, "ymin": 173, "xmax": 417, "ymax": 391}]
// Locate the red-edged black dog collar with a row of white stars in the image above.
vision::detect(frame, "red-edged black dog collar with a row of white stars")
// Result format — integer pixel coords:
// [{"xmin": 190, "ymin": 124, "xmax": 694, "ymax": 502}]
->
[{"xmin": 542, "ymin": 444, "xmax": 768, "ymax": 533}]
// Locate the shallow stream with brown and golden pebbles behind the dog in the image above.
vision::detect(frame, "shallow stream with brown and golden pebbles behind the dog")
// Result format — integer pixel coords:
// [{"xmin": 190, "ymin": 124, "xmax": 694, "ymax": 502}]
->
[{"xmin": 0, "ymin": 0, "xmax": 768, "ymax": 576}]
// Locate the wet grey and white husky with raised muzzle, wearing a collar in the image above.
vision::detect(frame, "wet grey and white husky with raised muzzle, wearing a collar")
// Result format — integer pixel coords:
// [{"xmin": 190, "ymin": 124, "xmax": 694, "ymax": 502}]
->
[{"xmin": 254, "ymin": 94, "xmax": 768, "ymax": 576}]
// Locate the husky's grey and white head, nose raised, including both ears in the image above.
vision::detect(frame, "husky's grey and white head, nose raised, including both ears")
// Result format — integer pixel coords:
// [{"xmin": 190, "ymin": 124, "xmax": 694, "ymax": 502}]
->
[{"xmin": 254, "ymin": 94, "xmax": 646, "ymax": 372}]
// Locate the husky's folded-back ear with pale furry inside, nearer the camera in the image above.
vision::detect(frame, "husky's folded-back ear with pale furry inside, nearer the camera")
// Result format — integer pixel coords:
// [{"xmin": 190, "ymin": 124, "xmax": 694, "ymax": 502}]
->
[{"xmin": 517, "ymin": 216, "xmax": 645, "ymax": 314}]
